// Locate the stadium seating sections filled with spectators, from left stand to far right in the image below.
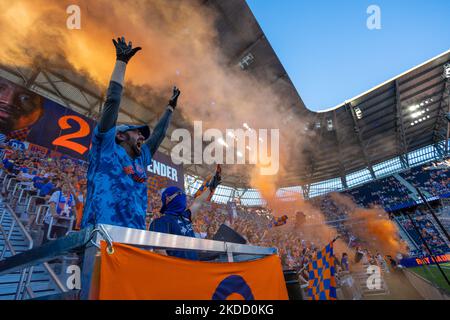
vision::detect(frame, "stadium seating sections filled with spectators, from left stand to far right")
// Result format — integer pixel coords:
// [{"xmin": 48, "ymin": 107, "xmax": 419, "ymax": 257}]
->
[{"xmin": 0, "ymin": 140, "xmax": 450, "ymax": 298}]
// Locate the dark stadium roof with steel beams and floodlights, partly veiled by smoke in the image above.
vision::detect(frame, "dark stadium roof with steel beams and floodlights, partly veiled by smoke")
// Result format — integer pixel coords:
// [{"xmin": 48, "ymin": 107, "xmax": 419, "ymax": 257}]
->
[{"xmin": 0, "ymin": 0, "xmax": 450, "ymax": 187}]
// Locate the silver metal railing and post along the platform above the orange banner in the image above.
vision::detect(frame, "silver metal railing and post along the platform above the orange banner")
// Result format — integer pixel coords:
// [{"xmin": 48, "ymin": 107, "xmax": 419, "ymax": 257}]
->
[{"xmin": 0, "ymin": 225, "xmax": 277, "ymax": 299}]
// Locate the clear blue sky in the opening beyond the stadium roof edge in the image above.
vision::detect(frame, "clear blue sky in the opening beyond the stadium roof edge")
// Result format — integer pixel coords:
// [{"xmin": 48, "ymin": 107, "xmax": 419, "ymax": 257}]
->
[{"xmin": 247, "ymin": 0, "xmax": 450, "ymax": 111}]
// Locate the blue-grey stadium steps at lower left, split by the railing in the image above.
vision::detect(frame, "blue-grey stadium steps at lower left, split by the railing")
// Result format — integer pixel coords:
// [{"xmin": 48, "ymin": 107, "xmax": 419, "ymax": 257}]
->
[{"xmin": 0, "ymin": 200, "xmax": 60, "ymax": 300}]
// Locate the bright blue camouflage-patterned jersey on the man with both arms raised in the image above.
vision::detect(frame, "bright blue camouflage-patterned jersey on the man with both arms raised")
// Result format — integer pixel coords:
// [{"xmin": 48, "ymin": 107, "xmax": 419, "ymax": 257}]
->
[{"xmin": 81, "ymin": 126, "xmax": 151, "ymax": 229}]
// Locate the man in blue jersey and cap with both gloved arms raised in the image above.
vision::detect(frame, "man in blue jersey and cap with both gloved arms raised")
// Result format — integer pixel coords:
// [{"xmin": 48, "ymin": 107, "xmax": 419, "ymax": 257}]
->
[{"xmin": 82, "ymin": 37, "xmax": 180, "ymax": 229}]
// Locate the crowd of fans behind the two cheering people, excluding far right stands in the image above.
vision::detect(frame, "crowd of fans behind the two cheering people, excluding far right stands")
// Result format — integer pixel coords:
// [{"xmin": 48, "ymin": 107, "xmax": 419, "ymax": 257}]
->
[{"xmin": 2, "ymin": 143, "xmax": 404, "ymax": 278}]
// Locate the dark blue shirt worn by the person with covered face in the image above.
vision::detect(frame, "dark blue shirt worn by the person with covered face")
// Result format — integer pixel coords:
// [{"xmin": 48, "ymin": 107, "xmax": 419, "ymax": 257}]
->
[{"xmin": 150, "ymin": 210, "xmax": 198, "ymax": 260}]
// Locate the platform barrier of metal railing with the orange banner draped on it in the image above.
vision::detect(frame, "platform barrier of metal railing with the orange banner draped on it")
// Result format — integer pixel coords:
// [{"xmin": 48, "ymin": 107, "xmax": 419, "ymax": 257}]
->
[{"xmin": 0, "ymin": 225, "xmax": 302, "ymax": 300}]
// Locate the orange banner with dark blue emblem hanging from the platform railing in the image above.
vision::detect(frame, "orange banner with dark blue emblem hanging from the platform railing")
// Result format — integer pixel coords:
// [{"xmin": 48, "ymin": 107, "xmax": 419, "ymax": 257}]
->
[{"xmin": 99, "ymin": 243, "xmax": 288, "ymax": 300}]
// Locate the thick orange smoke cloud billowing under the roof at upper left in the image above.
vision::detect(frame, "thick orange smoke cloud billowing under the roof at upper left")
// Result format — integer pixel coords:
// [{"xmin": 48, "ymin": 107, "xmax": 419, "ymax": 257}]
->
[{"xmin": 0, "ymin": 0, "xmax": 308, "ymax": 182}]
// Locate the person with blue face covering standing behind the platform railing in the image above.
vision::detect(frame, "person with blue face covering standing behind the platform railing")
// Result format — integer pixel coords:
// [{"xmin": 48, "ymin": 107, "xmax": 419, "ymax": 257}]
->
[{"xmin": 150, "ymin": 187, "xmax": 198, "ymax": 260}]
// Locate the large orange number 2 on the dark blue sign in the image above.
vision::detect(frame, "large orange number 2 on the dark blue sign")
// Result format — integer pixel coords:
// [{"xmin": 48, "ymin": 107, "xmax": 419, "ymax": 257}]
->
[{"xmin": 52, "ymin": 116, "xmax": 91, "ymax": 154}]
